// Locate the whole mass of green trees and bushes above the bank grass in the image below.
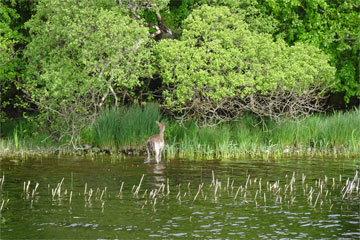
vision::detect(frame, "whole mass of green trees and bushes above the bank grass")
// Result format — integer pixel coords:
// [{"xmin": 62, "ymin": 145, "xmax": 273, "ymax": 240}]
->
[{"xmin": 0, "ymin": 0, "xmax": 360, "ymax": 144}]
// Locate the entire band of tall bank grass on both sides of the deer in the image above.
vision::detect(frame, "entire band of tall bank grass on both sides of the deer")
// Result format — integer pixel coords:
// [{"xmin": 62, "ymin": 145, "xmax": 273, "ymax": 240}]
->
[{"xmin": 0, "ymin": 105, "xmax": 360, "ymax": 159}]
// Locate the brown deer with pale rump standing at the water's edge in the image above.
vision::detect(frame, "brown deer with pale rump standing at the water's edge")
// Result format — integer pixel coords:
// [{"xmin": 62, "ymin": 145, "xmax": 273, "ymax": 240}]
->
[{"xmin": 145, "ymin": 121, "xmax": 167, "ymax": 163}]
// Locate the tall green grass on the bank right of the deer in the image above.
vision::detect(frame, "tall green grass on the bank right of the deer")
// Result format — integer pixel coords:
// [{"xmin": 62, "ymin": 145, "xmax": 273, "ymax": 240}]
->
[{"xmin": 166, "ymin": 110, "xmax": 360, "ymax": 159}]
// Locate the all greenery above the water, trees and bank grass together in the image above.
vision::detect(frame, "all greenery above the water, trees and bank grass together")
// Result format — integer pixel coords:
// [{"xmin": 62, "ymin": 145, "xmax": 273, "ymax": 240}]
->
[{"xmin": 0, "ymin": 0, "xmax": 360, "ymax": 155}]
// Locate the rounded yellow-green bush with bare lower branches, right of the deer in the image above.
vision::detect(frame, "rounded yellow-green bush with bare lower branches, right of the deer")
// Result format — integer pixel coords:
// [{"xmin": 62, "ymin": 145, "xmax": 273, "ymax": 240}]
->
[{"xmin": 155, "ymin": 6, "xmax": 334, "ymax": 123}]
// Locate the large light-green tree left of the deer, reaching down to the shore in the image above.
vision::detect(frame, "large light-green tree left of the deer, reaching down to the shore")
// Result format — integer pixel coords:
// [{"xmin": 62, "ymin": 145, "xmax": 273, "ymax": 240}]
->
[{"xmin": 24, "ymin": 0, "xmax": 152, "ymax": 146}]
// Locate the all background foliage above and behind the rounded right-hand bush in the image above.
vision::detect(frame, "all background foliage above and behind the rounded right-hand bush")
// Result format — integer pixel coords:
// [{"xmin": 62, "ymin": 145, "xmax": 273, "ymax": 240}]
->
[{"xmin": 167, "ymin": 0, "xmax": 360, "ymax": 101}]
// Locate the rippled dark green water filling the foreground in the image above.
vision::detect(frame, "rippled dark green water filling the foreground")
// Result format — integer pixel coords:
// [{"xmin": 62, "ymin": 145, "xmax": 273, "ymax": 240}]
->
[{"xmin": 0, "ymin": 157, "xmax": 360, "ymax": 239}]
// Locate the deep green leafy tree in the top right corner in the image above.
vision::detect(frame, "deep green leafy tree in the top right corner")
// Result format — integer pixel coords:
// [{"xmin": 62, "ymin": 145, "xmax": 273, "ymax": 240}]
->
[{"xmin": 263, "ymin": 0, "xmax": 360, "ymax": 100}]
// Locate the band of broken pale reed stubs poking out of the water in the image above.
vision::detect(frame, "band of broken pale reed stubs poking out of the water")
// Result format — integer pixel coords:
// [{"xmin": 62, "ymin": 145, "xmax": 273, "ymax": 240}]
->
[{"xmin": 0, "ymin": 170, "xmax": 360, "ymax": 214}]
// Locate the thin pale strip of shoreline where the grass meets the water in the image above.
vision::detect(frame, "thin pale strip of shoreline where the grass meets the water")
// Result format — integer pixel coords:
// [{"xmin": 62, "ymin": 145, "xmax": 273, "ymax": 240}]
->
[{"xmin": 0, "ymin": 143, "xmax": 360, "ymax": 161}]
